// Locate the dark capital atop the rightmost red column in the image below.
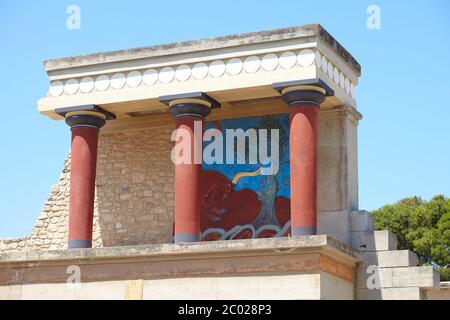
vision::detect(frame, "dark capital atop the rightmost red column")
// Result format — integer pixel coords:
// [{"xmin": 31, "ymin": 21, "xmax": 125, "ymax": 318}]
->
[{"xmin": 272, "ymin": 79, "xmax": 334, "ymax": 106}]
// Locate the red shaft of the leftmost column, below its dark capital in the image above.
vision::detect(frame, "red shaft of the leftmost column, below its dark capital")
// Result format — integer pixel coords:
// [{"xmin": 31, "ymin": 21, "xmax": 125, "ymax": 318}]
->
[{"xmin": 69, "ymin": 127, "xmax": 99, "ymax": 248}]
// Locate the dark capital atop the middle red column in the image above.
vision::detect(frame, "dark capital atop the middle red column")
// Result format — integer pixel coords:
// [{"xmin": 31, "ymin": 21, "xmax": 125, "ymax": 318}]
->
[{"xmin": 159, "ymin": 92, "xmax": 220, "ymax": 118}]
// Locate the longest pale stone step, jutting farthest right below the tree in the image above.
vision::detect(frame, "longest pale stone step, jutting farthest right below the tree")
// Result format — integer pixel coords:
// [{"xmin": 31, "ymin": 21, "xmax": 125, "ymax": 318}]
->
[{"xmin": 356, "ymin": 266, "xmax": 440, "ymax": 289}]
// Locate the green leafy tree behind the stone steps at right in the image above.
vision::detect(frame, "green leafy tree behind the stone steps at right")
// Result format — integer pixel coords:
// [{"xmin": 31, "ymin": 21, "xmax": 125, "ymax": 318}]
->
[{"xmin": 372, "ymin": 195, "xmax": 450, "ymax": 281}]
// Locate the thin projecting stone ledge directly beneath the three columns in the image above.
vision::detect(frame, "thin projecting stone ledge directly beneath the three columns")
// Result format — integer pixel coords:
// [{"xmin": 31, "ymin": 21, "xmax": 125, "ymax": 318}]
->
[{"xmin": 0, "ymin": 235, "xmax": 361, "ymax": 268}]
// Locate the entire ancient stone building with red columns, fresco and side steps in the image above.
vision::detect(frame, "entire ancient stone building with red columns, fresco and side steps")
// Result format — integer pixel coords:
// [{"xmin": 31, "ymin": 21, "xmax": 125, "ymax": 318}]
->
[{"xmin": 0, "ymin": 25, "xmax": 448, "ymax": 299}]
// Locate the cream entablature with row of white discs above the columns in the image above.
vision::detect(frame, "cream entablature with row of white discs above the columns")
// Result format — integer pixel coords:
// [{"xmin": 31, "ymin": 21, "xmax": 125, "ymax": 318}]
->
[{"xmin": 38, "ymin": 25, "xmax": 360, "ymax": 119}]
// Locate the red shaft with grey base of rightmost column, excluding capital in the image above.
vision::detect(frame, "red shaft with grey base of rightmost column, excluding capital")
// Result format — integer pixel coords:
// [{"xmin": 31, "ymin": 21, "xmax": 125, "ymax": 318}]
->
[{"xmin": 289, "ymin": 102, "xmax": 319, "ymax": 236}]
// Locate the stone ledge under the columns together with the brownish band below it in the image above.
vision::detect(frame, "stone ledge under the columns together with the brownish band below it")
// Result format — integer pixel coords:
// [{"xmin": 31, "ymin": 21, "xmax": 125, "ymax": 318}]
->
[{"xmin": 0, "ymin": 235, "xmax": 360, "ymax": 286}]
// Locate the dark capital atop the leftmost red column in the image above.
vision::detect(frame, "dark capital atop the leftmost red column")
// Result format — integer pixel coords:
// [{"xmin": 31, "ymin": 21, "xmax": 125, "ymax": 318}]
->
[{"xmin": 55, "ymin": 104, "xmax": 116, "ymax": 129}]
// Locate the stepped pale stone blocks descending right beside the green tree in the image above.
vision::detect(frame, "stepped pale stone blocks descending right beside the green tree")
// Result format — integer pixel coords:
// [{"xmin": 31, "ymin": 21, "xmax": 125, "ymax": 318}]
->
[{"xmin": 350, "ymin": 211, "xmax": 440, "ymax": 300}]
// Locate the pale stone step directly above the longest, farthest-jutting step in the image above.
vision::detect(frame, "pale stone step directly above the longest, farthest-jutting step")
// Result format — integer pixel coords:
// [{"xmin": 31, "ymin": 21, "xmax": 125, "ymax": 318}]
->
[{"xmin": 359, "ymin": 250, "xmax": 417, "ymax": 269}]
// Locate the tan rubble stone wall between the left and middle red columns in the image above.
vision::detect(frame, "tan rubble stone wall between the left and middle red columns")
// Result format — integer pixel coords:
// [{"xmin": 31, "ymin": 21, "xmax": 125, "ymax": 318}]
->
[{"xmin": 97, "ymin": 127, "xmax": 175, "ymax": 246}]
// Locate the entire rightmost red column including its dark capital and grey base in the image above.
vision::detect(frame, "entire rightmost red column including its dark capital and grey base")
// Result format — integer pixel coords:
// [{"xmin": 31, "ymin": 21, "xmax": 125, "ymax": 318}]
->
[{"xmin": 272, "ymin": 79, "xmax": 328, "ymax": 237}]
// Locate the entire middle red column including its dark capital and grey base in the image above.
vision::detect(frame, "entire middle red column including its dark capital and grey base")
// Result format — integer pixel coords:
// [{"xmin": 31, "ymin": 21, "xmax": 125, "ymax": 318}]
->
[{"xmin": 159, "ymin": 92, "xmax": 220, "ymax": 243}]
